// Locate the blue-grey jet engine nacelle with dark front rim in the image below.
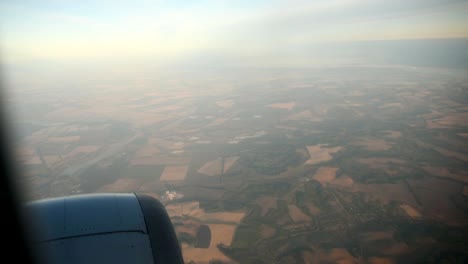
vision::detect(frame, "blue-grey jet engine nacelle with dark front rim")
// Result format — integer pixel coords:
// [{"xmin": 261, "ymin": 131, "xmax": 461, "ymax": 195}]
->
[{"xmin": 26, "ymin": 194, "xmax": 183, "ymax": 264}]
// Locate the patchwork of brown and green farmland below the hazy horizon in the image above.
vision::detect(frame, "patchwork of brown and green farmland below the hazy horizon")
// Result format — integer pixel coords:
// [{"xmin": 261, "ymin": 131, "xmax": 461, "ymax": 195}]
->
[{"xmin": 16, "ymin": 65, "xmax": 468, "ymax": 263}]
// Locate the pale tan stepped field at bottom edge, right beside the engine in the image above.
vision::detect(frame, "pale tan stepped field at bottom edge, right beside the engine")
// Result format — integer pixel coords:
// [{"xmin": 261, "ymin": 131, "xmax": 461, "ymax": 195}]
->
[{"xmin": 182, "ymin": 224, "xmax": 236, "ymax": 264}]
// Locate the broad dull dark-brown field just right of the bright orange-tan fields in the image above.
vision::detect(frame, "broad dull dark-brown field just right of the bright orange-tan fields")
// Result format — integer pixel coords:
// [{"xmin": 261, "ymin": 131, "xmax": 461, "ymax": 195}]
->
[{"xmin": 351, "ymin": 182, "xmax": 418, "ymax": 207}]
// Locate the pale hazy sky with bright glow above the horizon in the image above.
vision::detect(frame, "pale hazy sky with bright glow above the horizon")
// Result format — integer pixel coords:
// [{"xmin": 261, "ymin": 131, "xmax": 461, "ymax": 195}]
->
[{"xmin": 0, "ymin": 0, "xmax": 468, "ymax": 62}]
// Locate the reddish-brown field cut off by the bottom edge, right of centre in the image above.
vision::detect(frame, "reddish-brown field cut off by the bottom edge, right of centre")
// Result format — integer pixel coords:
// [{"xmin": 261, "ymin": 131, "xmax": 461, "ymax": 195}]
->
[{"xmin": 302, "ymin": 248, "xmax": 359, "ymax": 264}]
